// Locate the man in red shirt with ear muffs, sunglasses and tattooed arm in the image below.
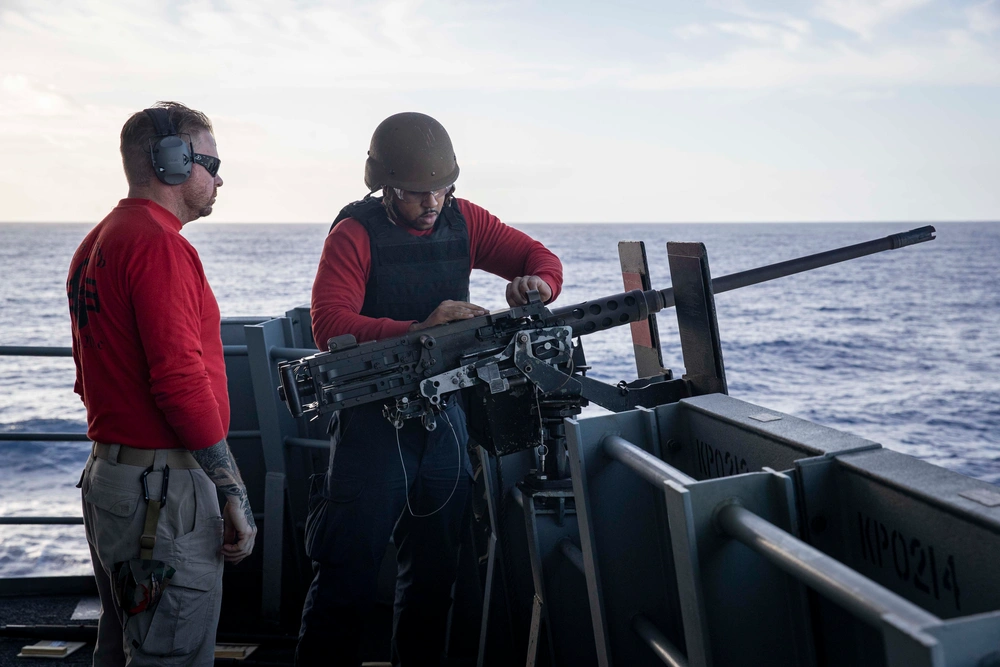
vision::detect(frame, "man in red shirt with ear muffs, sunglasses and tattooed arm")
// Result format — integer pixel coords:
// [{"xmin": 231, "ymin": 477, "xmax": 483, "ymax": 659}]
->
[{"xmin": 66, "ymin": 102, "xmax": 257, "ymax": 667}]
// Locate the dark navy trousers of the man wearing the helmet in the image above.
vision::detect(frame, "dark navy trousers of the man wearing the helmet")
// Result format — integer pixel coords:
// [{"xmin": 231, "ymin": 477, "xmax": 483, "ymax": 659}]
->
[{"xmin": 295, "ymin": 400, "xmax": 471, "ymax": 667}]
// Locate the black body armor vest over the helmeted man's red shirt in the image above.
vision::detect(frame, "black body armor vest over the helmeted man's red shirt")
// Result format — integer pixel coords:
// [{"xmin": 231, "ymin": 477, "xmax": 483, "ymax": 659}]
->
[{"xmin": 334, "ymin": 197, "xmax": 472, "ymax": 322}]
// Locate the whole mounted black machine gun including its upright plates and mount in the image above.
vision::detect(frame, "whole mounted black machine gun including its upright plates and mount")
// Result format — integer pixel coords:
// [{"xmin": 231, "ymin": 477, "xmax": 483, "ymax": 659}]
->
[{"xmin": 278, "ymin": 227, "xmax": 935, "ymax": 488}]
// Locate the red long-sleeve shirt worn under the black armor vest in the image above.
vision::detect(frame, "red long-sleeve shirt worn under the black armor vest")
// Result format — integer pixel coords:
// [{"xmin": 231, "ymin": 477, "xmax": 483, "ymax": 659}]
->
[{"xmin": 311, "ymin": 198, "xmax": 562, "ymax": 350}]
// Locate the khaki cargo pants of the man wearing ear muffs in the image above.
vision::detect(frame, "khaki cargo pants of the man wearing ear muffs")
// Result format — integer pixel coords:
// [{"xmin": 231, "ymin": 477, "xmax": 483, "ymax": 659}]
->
[{"xmin": 80, "ymin": 445, "xmax": 223, "ymax": 667}]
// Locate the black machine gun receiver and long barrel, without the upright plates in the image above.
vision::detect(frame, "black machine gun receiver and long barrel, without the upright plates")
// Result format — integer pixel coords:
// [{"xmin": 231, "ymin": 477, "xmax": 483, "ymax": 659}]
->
[{"xmin": 278, "ymin": 227, "xmax": 935, "ymax": 438}]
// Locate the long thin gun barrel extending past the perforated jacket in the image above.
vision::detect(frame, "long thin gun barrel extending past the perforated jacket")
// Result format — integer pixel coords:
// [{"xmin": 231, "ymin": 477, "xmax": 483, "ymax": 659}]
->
[{"xmin": 659, "ymin": 225, "xmax": 937, "ymax": 308}]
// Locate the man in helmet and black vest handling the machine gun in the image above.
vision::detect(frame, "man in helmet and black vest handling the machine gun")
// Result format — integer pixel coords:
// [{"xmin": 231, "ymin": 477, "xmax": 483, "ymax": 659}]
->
[{"xmin": 296, "ymin": 113, "xmax": 562, "ymax": 666}]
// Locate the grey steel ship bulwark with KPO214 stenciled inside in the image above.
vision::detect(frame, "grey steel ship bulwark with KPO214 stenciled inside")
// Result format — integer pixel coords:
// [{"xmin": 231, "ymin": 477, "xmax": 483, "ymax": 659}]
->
[{"xmin": 560, "ymin": 394, "xmax": 1000, "ymax": 667}]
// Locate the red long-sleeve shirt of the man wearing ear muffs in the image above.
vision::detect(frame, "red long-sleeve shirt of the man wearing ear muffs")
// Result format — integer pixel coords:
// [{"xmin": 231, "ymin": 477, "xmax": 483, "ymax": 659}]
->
[{"xmin": 66, "ymin": 199, "xmax": 229, "ymax": 449}]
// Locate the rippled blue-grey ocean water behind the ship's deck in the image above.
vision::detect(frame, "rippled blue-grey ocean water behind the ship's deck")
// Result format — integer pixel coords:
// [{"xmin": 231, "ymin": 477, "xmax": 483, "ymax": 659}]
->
[{"xmin": 0, "ymin": 222, "xmax": 1000, "ymax": 577}]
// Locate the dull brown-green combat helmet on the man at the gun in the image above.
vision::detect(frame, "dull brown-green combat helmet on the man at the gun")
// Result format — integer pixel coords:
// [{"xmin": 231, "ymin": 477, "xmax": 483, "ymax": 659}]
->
[{"xmin": 365, "ymin": 112, "xmax": 458, "ymax": 192}]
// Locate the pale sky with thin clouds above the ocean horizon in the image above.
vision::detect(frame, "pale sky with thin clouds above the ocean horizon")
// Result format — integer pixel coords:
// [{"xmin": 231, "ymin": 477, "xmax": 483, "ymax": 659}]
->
[{"xmin": 0, "ymin": 0, "xmax": 1000, "ymax": 223}]
